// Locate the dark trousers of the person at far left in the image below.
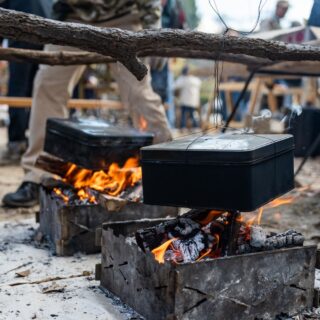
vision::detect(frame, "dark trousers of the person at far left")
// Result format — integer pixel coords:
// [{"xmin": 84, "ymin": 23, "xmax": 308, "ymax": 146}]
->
[{"xmin": 8, "ymin": 41, "xmax": 42, "ymax": 142}]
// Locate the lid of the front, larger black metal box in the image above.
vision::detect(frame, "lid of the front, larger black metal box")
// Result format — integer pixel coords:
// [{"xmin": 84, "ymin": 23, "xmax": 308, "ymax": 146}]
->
[{"xmin": 141, "ymin": 133, "xmax": 294, "ymax": 164}]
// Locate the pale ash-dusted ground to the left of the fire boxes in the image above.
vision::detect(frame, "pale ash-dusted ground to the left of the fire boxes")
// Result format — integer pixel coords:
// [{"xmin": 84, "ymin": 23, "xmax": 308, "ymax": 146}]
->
[{"xmin": 0, "ymin": 128, "xmax": 139, "ymax": 320}]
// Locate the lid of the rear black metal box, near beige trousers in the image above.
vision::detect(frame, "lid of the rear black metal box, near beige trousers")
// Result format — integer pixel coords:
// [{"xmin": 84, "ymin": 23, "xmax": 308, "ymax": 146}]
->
[{"xmin": 47, "ymin": 119, "xmax": 153, "ymax": 147}]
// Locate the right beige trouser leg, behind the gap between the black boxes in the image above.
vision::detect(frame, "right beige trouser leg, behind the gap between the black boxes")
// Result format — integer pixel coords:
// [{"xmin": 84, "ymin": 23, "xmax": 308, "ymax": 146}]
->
[{"xmin": 111, "ymin": 63, "xmax": 172, "ymax": 143}]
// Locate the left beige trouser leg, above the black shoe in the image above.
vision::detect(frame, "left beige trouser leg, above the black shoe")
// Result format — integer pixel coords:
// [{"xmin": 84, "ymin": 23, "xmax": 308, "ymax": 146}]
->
[{"xmin": 22, "ymin": 45, "xmax": 85, "ymax": 183}]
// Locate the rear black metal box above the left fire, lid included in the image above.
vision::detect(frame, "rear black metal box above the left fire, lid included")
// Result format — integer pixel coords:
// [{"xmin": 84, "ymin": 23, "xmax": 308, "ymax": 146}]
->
[{"xmin": 44, "ymin": 119, "xmax": 153, "ymax": 170}]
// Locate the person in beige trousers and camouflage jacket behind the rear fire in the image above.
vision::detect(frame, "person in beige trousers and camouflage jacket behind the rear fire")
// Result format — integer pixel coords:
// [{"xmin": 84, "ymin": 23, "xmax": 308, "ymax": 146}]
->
[{"xmin": 2, "ymin": 0, "xmax": 171, "ymax": 207}]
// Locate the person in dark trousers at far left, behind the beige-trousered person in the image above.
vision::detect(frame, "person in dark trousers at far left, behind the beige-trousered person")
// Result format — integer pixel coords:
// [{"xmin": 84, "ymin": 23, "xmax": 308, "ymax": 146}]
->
[{"xmin": 0, "ymin": 0, "xmax": 52, "ymax": 165}]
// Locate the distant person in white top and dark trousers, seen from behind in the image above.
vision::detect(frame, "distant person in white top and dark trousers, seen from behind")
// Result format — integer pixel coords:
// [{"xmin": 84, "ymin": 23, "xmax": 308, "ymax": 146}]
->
[{"xmin": 174, "ymin": 66, "xmax": 201, "ymax": 129}]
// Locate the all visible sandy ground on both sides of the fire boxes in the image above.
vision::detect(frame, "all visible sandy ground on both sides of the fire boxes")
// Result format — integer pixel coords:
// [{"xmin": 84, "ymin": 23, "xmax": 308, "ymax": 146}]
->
[{"xmin": 0, "ymin": 128, "xmax": 320, "ymax": 320}]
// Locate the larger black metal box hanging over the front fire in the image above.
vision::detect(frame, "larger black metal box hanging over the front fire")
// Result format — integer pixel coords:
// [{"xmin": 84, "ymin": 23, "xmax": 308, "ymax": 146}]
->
[{"xmin": 141, "ymin": 134, "xmax": 294, "ymax": 211}]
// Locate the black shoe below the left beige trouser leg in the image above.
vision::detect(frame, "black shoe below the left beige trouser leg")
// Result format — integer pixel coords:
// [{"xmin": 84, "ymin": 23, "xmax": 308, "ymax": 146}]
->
[{"xmin": 2, "ymin": 182, "xmax": 39, "ymax": 208}]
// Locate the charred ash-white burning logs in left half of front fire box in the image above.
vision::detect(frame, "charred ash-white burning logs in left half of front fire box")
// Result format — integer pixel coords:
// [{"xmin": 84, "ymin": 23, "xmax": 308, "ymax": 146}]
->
[{"xmin": 135, "ymin": 210, "xmax": 224, "ymax": 263}]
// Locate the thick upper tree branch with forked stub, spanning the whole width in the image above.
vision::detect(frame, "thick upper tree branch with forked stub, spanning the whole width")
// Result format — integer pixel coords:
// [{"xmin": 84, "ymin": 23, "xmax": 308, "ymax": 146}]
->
[{"xmin": 0, "ymin": 9, "xmax": 320, "ymax": 80}]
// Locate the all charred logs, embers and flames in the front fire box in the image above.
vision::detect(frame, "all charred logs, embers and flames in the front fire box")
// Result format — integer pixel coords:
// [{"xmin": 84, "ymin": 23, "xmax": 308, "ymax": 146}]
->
[{"xmin": 152, "ymin": 197, "xmax": 296, "ymax": 263}]
